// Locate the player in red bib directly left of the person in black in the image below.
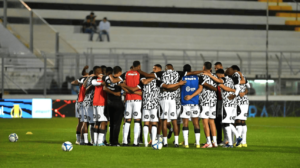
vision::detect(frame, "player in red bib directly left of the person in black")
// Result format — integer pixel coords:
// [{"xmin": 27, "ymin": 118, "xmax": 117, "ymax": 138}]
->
[{"xmin": 91, "ymin": 67, "xmax": 108, "ymax": 146}]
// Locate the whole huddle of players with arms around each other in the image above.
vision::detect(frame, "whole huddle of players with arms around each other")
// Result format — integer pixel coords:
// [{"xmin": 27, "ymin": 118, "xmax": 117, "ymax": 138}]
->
[{"xmin": 72, "ymin": 61, "xmax": 250, "ymax": 148}]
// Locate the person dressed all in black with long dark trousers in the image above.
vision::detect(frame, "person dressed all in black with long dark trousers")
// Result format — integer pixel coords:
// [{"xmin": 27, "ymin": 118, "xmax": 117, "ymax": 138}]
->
[{"xmin": 104, "ymin": 66, "xmax": 124, "ymax": 146}]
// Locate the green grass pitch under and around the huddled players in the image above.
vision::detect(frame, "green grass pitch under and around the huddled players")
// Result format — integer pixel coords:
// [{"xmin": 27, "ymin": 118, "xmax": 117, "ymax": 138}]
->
[{"xmin": 0, "ymin": 118, "xmax": 300, "ymax": 168}]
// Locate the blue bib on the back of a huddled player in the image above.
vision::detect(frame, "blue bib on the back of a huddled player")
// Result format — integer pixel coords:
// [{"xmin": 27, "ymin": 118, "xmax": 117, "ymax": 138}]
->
[{"xmin": 181, "ymin": 75, "xmax": 199, "ymax": 105}]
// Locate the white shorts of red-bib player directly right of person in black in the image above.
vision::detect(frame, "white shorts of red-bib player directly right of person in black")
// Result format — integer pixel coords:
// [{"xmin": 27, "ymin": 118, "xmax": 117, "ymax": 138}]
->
[{"xmin": 124, "ymin": 100, "xmax": 142, "ymax": 119}]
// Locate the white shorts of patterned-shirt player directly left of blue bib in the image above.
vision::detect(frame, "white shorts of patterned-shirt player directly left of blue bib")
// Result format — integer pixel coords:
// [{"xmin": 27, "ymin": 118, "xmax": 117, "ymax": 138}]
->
[{"xmin": 160, "ymin": 100, "xmax": 177, "ymax": 121}]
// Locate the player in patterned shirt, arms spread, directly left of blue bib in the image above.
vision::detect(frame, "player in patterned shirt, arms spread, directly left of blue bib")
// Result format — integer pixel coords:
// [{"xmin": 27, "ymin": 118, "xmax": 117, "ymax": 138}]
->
[{"xmin": 138, "ymin": 64, "xmax": 202, "ymax": 147}]
